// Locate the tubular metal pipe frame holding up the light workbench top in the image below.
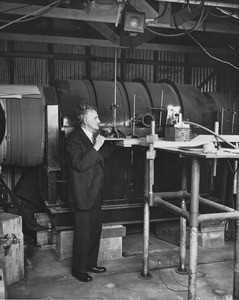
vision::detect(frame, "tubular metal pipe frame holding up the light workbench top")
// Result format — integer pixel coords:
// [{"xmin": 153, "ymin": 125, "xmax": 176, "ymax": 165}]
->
[{"xmin": 140, "ymin": 128, "xmax": 239, "ymax": 300}]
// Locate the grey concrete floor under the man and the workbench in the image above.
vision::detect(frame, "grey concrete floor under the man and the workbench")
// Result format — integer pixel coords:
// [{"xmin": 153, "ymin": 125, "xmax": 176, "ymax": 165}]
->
[{"xmin": 7, "ymin": 226, "xmax": 234, "ymax": 300}]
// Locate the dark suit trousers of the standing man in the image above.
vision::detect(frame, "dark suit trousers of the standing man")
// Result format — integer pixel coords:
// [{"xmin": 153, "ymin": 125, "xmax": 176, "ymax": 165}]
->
[{"xmin": 72, "ymin": 189, "xmax": 102, "ymax": 273}]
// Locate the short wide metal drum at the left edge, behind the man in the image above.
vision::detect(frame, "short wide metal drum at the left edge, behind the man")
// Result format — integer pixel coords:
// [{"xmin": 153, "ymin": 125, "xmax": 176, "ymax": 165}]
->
[{"xmin": 0, "ymin": 92, "xmax": 45, "ymax": 166}]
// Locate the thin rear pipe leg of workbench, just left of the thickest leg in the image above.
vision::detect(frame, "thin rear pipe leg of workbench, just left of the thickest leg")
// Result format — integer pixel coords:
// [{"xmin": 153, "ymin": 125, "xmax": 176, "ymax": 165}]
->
[{"xmin": 177, "ymin": 159, "xmax": 187, "ymax": 274}]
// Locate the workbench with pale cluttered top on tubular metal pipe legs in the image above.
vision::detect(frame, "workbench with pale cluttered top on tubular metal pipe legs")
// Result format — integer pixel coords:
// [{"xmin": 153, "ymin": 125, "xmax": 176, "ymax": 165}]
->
[{"xmin": 111, "ymin": 134, "xmax": 239, "ymax": 300}]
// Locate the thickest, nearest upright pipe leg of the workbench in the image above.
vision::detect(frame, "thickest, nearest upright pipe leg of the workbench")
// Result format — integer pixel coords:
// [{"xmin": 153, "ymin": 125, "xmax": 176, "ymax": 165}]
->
[{"xmin": 188, "ymin": 158, "xmax": 200, "ymax": 300}]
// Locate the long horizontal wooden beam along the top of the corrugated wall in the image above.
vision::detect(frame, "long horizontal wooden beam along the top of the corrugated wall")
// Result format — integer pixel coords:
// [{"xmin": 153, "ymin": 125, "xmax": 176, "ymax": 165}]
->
[{"xmin": 0, "ymin": 32, "xmax": 232, "ymax": 58}]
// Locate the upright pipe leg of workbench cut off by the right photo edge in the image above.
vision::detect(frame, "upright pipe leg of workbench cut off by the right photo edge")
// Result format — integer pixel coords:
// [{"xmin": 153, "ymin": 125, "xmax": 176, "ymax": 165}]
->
[{"xmin": 233, "ymin": 162, "xmax": 239, "ymax": 300}]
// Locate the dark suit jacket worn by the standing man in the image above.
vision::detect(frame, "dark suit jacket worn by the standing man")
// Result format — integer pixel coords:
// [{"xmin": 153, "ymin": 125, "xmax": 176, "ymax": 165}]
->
[{"xmin": 66, "ymin": 128, "xmax": 111, "ymax": 212}]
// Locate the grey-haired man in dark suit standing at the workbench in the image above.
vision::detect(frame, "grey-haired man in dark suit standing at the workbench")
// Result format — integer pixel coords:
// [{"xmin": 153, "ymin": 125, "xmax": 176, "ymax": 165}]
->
[{"xmin": 66, "ymin": 105, "xmax": 112, "ymax": 282}]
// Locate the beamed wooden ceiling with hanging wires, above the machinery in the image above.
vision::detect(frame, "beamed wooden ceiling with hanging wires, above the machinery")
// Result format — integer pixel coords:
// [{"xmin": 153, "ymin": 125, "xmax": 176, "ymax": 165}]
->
[{"xmin": 0, "ymin": 0, "xmax": 239, "ymax": 54}]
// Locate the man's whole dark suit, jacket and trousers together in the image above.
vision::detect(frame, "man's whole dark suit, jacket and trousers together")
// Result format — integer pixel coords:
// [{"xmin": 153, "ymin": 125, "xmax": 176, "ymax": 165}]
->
[{"xmin": 66, "ymin": 128, "xmax": 111, "ymax": 273}]
